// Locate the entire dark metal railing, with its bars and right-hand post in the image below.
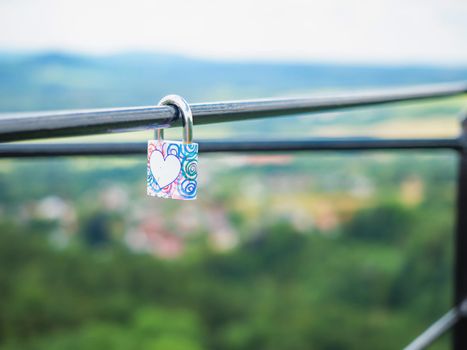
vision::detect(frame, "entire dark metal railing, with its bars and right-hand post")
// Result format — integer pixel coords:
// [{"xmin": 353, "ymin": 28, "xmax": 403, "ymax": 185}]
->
[{"xmin": 0, "ymin": 82, "xmax": 467, "ymax": 350}]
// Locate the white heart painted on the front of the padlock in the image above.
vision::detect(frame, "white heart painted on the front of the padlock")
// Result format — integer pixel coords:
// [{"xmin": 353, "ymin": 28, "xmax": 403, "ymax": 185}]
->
[{"xmin": 149, "ymin": 150, "xmax": 182, "ymax": 188}]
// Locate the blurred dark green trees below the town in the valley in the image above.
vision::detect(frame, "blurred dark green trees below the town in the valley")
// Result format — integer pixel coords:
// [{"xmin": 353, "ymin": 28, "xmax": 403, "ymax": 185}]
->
[{"xmin": 0, "ymin": 203, "xmax": 451, "ymax": 350}]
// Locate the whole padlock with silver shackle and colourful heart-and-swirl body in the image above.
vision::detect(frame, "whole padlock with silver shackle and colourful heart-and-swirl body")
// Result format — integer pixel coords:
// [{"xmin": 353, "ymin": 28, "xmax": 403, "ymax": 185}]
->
[{"xmin": 147, "ymin": 95, "xmax": 198, "ymax": 200}]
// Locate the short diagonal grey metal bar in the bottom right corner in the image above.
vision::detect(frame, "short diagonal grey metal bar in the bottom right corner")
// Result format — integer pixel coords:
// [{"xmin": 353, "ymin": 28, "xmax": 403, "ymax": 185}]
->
[{"xmin": 404, "ymin": 300, "xmax": 467, "ymax": 350}]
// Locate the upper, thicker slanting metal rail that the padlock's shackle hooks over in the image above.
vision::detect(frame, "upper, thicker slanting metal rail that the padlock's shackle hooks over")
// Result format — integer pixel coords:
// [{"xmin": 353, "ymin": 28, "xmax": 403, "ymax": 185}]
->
[{"xmin": 0, "ymin": 82, "xmax": 467, "ymax": 142}]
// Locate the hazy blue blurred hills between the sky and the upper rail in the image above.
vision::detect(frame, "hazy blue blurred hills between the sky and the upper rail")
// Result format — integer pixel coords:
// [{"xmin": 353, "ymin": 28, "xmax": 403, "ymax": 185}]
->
[{"xmin": 0, "ymin": 52, "xmax": 467, "ymax": 111}]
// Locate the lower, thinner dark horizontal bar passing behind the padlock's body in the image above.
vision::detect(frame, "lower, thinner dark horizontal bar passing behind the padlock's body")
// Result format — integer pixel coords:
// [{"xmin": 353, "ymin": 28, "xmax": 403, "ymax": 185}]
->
[{"xmin": 0, "ymin": 138, "xmax": 461, "ymax": 158}]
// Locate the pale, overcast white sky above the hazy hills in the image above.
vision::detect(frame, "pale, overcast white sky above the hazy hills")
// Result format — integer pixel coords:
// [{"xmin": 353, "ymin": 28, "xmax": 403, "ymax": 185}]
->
[{"xmin": 0, "ymin": 0, "xmax": 467, "ymax": 66}]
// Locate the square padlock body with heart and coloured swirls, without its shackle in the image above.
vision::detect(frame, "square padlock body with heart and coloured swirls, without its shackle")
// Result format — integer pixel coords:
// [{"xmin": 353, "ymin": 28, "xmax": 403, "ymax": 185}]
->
[{"xmin": 147, "ymin": 140, "xmax": 198, "ymax": 200}]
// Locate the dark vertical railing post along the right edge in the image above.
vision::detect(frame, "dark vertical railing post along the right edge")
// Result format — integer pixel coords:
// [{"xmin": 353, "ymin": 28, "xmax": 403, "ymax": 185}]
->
[{"xmin": 453, "ymin": 118, "xmax": 467, "ymax": 350}]
